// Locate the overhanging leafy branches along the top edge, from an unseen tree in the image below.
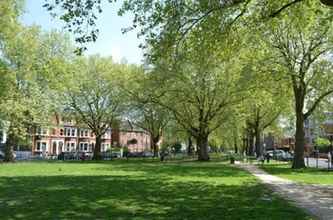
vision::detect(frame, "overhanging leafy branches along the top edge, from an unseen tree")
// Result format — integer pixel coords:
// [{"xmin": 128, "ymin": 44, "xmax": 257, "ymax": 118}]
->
[{"xmin": 43, "ymin": 0, "xmax": 332, "ymax": 53}]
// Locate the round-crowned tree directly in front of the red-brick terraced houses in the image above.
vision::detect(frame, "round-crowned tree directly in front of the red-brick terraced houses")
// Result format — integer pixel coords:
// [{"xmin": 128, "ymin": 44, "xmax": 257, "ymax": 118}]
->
[{"xmin": 58, "ymin": 56, "xmax": 122, "ymax": 160}]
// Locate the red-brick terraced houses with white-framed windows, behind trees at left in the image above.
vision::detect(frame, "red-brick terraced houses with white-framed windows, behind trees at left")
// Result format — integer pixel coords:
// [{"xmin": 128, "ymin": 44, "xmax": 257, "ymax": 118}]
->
[{"xmin": 32, "ymin": 115, "xmax": 150, "ymax": 157}]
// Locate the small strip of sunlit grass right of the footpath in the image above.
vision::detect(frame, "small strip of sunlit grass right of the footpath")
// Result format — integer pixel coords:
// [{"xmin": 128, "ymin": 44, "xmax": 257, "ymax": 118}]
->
[{"xmin": 260, "ymin": 163, "xmax": 333, "ymax": 184}]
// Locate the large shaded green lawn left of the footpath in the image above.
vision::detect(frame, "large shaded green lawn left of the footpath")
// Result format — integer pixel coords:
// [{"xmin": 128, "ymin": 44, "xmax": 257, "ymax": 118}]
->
[{"xmin": 0, "ymin": 160, "xmax": 310, "ymax": 220}]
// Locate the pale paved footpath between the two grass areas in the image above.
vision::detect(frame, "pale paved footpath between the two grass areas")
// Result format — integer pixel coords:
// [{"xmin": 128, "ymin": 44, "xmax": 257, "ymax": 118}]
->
[{"xmin": 237, "ymin": 164, "xmax": 333, "ymax": 220}]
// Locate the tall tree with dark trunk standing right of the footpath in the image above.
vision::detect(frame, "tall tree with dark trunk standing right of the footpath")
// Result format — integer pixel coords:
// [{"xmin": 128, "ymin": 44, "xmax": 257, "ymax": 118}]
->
[{"xmin": 263, "ymin": 3, "xmax": 333, "ymax": 169}]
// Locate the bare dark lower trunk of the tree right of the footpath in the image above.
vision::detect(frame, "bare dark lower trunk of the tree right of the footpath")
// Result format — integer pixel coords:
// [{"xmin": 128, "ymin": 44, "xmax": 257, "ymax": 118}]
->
[{"xmin": 292, "ymin": 112, "xmax": 305, "ymax": 169}]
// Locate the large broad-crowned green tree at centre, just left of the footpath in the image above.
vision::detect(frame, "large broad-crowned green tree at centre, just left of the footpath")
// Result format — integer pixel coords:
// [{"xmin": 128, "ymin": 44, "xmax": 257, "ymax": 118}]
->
[{"xmin": 145, "ymin": 23, "xmax": 247, "ymax": 160}]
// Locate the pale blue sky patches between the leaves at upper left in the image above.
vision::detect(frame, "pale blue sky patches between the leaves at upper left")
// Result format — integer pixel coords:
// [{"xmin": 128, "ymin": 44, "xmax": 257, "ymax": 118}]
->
[{"xmin": 21, "ymin": 0, "xmax": 142, "ymax": 63}]
